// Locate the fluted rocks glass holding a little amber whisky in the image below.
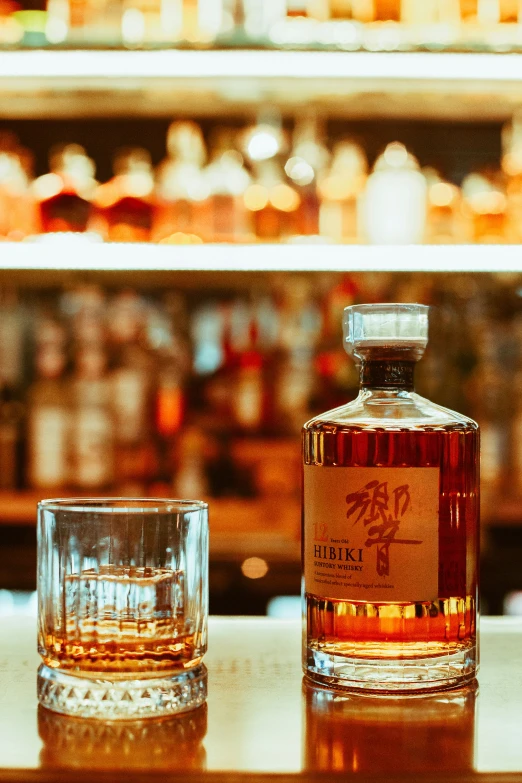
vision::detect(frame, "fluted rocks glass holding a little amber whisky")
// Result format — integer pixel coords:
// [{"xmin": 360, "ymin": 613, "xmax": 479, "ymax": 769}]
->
[{"xmin": 38, "ymin": 498, "xmax": 208, "ymax": 720}]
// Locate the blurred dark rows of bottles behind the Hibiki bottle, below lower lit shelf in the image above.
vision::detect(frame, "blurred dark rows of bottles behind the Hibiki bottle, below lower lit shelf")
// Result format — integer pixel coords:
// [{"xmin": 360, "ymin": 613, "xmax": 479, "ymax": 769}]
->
[{"xmin": 0, "ymin": 273, "xmax": 522, "ymax": 500}]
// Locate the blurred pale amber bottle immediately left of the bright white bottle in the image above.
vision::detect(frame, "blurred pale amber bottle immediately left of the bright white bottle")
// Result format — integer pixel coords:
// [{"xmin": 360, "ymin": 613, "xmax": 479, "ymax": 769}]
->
[{"xmin": 318, "ymin": 141, "xmax": 368, "ymax": 244}]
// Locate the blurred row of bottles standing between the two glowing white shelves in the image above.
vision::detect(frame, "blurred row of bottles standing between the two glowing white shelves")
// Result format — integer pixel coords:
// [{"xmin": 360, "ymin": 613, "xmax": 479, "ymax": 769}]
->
[{"xmin": 0, "ymin": 115, "xmax": 522, "ymax": 244}]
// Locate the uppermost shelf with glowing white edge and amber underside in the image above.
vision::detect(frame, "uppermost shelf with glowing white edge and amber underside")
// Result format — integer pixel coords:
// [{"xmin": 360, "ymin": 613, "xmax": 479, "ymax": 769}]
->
[{"xmin": 0, "ymin": 49, "xmax": 522, "ymax": 122}]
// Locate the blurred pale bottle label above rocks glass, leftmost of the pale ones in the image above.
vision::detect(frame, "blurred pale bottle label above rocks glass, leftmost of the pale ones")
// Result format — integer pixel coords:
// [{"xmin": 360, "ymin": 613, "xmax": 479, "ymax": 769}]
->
[{"xmin": 30, "ymin": 407, "xmax": 69, "ymax": 487}]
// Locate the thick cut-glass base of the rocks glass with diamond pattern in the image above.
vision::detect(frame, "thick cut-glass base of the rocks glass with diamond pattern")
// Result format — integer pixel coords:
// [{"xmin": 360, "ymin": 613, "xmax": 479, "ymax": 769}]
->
[{"xmin": 37, "ymin": 664, "xmax": 207, "ymax": 720}]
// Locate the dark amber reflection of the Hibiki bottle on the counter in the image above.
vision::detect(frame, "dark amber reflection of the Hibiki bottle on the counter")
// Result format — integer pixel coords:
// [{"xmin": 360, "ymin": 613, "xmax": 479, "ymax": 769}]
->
[{"xmin": 303, "ymin": 680, "xmax": 478, "ymax": 773}]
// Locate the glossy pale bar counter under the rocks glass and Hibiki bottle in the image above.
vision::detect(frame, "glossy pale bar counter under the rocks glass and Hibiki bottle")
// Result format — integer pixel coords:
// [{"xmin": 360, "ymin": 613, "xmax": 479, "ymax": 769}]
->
[{"xmin": 0, "ymin": 616, "xmax": 522, "ymax": 783}]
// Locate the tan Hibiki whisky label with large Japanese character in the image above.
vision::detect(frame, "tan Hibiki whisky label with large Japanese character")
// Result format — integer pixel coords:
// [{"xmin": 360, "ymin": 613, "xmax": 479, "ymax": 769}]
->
[{"xmin": 303, "ymin": 465, "xmax": 440, "ymax": 603}]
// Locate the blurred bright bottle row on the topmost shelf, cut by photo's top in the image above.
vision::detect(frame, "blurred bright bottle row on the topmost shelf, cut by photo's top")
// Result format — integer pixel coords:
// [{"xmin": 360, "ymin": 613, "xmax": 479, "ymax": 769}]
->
[{"xmin": 0, "ymin": 0, "xmax": 522, "ymax": 50}]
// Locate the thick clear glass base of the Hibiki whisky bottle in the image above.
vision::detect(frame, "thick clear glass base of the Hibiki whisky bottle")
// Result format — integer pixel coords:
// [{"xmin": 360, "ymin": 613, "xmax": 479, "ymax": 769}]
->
[{"xmin": 305, "ymin": 646, "xmax": 478, "ymax": 694}]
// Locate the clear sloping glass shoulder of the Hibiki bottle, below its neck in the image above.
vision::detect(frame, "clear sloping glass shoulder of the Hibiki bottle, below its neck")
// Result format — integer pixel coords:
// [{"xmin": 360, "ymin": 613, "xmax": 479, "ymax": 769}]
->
[{"xmin": 303, "ymin": 390, "xmax": 479, "ymax": 432}]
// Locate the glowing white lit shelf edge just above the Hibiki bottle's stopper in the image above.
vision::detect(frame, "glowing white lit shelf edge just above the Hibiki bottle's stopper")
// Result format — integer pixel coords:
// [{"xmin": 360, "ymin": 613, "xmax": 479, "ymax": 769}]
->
[{"xmin": 0, "ymin": 242, "xmax": 522, "ymax": 276}]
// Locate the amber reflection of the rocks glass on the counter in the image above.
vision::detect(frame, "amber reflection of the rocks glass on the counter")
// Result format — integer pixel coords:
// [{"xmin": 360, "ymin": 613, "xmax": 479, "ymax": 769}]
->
[{"xmin": 38, "ymin": 704, "xmax": 207, "ymax": 772}]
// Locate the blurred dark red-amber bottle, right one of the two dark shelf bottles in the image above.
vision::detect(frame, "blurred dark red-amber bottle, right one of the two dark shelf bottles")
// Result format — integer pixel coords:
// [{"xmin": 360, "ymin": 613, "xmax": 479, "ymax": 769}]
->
[{"xmin": 93, "ymin": 147, "xmax": 154, "ymax": 242}]
